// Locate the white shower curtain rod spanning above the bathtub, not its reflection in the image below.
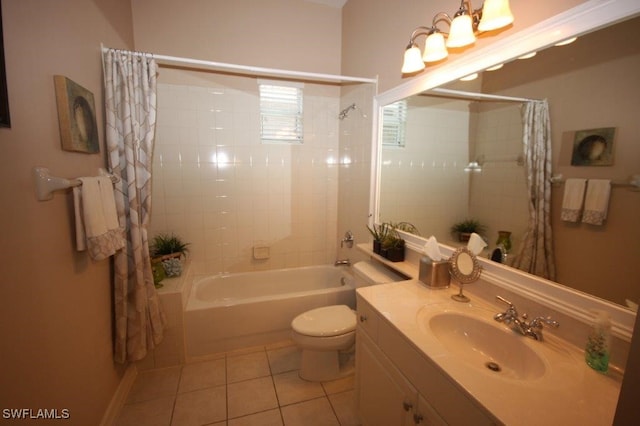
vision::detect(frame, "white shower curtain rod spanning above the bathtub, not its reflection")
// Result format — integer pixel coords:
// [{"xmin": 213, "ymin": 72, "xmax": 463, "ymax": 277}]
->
[{"xmin": 102, "ymin": 46, "xmax": 378, "ymax": 83}]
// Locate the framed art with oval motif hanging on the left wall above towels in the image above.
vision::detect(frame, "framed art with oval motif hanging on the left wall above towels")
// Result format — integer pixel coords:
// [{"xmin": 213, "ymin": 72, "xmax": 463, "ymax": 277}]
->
[{"xmin": 53, "ymin": 75, "xmax": 100, "ymax": 154}]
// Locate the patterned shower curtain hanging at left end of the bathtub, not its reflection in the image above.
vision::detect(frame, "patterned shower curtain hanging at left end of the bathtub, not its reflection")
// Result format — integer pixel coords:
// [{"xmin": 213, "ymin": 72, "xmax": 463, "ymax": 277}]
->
[{"xmin": 104, "ymin": 49, "xmax": 166, "ymax": 363}]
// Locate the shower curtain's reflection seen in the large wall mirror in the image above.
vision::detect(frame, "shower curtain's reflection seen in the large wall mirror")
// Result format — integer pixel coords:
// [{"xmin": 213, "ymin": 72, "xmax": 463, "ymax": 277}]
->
[{"xmin": 513, "ymin": 100, "xmax": 556, "ymax": 280}]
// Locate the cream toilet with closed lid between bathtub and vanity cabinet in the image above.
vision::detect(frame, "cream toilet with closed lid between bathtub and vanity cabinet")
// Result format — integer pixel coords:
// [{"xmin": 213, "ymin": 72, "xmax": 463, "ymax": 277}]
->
[{"xmin": 291, "ymin": 261, "xmax": 405, "ymax": 382}]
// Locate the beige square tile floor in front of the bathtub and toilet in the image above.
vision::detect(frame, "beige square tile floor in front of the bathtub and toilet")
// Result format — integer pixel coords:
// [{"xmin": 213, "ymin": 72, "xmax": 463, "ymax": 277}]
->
[{"xmin": 116, "ymin": 342, "xmax": 360, "ymax": 426}]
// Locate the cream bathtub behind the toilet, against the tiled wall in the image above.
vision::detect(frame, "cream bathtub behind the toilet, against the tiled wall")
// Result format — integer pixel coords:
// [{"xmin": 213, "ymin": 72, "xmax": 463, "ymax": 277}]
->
[{"xmin": 184, "ymin": 265, "xmax": 355, "ymax": 359}]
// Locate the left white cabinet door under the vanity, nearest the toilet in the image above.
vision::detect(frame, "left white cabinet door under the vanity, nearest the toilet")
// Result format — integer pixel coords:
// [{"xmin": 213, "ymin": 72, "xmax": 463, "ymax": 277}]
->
[{"xmin": 356, "ymin": 333, "xmax": 417, "ymax": 426}]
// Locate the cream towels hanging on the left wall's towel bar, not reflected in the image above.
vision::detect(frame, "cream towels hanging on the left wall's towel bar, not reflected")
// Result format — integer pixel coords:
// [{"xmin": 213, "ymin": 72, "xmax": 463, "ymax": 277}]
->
[{"xmin": 73, "ymin": 176, "xmax": 126, "ymax": 260}]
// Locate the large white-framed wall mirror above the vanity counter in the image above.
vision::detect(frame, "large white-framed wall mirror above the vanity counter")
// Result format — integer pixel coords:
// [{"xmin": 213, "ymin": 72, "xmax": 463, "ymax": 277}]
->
[{"xmin": 372, "ymin": 1, "xmax": 640, "ymax": 312}]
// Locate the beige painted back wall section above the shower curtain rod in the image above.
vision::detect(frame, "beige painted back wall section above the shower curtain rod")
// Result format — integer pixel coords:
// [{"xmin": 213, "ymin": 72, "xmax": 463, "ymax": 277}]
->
[{"xmin": 132, "ymin": 0, "xmax": 342, "ymax": 74}]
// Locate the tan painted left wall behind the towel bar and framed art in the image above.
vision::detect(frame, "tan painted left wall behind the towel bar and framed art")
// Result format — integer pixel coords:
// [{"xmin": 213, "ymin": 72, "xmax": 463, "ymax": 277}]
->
[{"xmin": 0, "ymin": 0, "xmax": 133, "ymax": 425}]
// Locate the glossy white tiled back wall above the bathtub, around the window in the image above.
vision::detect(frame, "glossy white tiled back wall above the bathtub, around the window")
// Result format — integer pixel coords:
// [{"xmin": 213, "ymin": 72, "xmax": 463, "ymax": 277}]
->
[{"xmin": 149, "ymin": 83, "xmax": 340, "ymax": 273}]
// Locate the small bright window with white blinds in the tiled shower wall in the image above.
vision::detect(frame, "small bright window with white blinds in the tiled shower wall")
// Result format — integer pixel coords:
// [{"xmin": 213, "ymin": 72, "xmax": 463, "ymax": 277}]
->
[{"xmin": 259, "ymin": 81, "xmax": 303, "ymax": 144}]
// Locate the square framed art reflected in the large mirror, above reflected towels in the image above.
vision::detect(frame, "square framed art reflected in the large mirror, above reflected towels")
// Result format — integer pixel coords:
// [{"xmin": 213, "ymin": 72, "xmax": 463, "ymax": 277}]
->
[{"xmin": 571, "ymin": 127, "xmax": 616, "ymax": 166}]
